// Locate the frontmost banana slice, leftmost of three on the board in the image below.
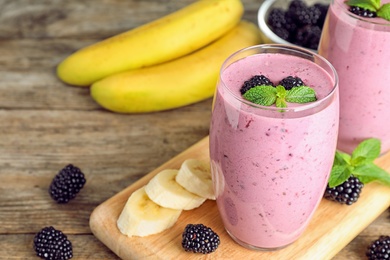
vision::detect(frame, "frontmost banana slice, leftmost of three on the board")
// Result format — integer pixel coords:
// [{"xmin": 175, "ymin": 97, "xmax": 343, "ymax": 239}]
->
[{"xmin": 117, "ymin": 187, "xmax": 181, "ymax": 237}]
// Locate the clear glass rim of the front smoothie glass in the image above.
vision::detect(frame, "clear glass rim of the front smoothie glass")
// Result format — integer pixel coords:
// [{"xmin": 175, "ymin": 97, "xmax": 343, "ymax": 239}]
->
[{"xmin": 218, "ymin": 43, "xmax": 339, "ymax": 113}]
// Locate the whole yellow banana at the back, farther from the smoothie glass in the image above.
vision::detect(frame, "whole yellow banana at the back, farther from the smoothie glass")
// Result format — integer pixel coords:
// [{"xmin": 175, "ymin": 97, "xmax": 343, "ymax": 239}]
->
[{"xmin": 57, "ymin": 0, "xmax": 244, "ymax": 86}]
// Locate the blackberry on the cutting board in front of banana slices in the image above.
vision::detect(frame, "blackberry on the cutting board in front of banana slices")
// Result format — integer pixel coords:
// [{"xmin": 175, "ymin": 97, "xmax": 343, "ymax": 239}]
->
[{"xmin": 181, "ymin": 224, "xmax": 220, "ymax": 254}]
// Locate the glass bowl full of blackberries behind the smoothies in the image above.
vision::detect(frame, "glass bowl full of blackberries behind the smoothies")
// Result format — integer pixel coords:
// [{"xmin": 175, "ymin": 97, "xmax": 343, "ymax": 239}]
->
[{"xmin": 258, "ymin": 0, "xmax": 330, "ymax": 51}]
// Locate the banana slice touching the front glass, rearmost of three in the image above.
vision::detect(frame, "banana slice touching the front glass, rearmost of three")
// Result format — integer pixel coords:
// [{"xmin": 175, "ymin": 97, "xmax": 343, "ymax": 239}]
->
[{"xmin": 176, "ymin": 159, "xmax": 215, "ymax": 200}]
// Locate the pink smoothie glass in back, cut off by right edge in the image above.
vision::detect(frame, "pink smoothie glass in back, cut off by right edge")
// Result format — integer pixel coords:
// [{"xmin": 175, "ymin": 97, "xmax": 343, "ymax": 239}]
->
[{"xmin": 318, "ymin": 0, "xmax": 390, "ymax": 153}]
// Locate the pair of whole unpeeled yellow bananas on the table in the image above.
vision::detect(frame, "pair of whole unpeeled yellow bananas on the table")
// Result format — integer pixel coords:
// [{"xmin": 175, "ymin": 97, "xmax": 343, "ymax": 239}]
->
[{"xmin": 57, "ymin": 0, "xmax": 261, "ymax": 113}]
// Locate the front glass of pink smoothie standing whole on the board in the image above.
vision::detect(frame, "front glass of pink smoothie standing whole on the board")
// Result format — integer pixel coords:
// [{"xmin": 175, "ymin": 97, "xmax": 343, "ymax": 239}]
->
[{"xmin": 210, "ymin": 44, "xmax": 339, "ymax": 250}]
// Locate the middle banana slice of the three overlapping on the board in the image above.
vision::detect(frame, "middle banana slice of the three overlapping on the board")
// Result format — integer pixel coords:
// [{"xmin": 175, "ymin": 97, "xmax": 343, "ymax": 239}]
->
[{"xmin": 145, "ymin": 169, "xmax": 206, "ymax": 210}]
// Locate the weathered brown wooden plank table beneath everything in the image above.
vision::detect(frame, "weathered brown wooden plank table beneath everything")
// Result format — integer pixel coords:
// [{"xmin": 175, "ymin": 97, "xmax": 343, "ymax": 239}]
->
[{"xmin": 0, "ymin": 0, "xmax": 390, "ymax": 259}]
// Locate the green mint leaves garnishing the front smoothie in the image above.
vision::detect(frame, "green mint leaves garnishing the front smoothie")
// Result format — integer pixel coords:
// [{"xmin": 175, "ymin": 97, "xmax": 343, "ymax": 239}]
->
[{"xmin": 243, "ymin": 85, "xmax": 317, "ymax": 108}]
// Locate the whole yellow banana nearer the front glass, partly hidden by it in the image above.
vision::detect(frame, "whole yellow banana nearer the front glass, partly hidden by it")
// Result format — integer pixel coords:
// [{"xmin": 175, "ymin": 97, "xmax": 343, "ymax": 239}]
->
[{"xmin": 91, "ymin": 21, "xmax": 261, "ymax": 113}]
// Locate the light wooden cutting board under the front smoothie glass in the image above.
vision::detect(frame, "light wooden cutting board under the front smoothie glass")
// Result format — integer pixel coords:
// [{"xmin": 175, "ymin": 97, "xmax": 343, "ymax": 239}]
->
[{"xmin": 90, "ymin": 137, "xmax": 390, "ymax": 260}]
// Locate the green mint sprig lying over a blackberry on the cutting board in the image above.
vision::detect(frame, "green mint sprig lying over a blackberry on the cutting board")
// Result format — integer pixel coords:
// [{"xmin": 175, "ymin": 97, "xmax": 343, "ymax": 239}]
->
[{"xmin": 328, "ymin": 138, "xmax": 390, "ymax": 188}]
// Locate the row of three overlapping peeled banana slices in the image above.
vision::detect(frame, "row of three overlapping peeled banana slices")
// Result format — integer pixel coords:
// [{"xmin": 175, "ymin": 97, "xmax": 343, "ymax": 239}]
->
[{"xmin": 117, "ymin": 159, "xmax": 215, "ymax": 237}]
